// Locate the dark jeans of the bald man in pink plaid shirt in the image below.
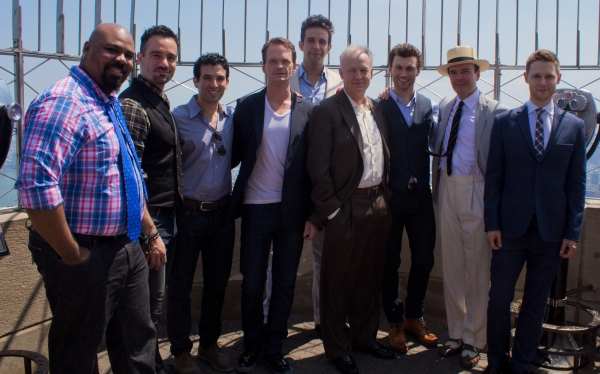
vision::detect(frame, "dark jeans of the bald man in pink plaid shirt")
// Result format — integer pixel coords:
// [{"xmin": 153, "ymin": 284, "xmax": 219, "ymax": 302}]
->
[{"xmin": 29, "ymin": 231, "xmax": 156, "ymax": 373}]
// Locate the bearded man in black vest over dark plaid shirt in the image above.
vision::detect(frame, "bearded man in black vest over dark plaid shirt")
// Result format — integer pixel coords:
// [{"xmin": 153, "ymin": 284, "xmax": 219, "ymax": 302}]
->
[{"xmin": 119, "ymin": 26, "xmax": 183, "ymax": 373}]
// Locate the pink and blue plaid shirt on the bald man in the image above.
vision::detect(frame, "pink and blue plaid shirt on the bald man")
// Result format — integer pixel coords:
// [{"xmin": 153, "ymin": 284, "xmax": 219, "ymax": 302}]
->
[{"xmin": 15, "ymin": 66, "xmax": 144, "ymax": 236}]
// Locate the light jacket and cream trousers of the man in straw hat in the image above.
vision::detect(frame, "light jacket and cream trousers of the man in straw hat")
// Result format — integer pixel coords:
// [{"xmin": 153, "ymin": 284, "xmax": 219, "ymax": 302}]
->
[{"xmin": 431, "ymin": 93, "xmax": 508, "ymax": 349}]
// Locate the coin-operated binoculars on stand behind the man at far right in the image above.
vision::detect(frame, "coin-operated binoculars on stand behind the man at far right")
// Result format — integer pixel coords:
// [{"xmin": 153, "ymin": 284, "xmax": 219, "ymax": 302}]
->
[{"xmin": 511, "ymin": 89, "xmax": 600, "ymax": 373}]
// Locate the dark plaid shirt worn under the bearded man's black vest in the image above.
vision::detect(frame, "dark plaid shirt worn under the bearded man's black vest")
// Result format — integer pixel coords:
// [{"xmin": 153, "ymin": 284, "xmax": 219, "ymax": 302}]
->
[{"xmin": 121, "ymin": 75, "xmax": 171, "ymax": 168}]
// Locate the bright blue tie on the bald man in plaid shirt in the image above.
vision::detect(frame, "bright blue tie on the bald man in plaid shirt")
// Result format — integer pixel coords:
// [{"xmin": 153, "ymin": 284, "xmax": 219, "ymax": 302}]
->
[{"xmin": 106, "ymin": 97, "xmax": 146, "ymax": 242}]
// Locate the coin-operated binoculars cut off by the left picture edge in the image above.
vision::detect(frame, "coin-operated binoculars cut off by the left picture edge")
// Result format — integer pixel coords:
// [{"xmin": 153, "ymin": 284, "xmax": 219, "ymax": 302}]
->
[{"xmin": 0, "ymin": 79, "xmax": 23, "ymax": 256}]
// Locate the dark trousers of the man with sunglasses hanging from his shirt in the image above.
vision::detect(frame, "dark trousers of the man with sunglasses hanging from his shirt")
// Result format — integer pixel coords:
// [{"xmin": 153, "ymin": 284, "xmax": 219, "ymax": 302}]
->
[{"xmin": 167, "ymin": 207, "xmax": 235, "ymax": 356}]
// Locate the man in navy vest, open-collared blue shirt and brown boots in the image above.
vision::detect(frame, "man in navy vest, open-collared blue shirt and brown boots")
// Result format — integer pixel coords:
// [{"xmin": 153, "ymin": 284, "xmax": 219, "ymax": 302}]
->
[{"xmin": 379, "ymin": 43, "xmax": 439, "ymax": 353}]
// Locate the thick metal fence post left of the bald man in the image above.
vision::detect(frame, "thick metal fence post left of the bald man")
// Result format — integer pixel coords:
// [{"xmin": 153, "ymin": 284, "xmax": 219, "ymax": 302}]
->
[{"xmin": 12, "ymin": 0, "xmax": 25, "ymax": 205}]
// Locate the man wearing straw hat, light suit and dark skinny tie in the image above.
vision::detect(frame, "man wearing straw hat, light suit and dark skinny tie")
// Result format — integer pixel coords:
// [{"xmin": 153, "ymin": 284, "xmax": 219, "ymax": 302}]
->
[{"xmin": 432, "ymin": 46, "xmax": 508, "ymax": 368}]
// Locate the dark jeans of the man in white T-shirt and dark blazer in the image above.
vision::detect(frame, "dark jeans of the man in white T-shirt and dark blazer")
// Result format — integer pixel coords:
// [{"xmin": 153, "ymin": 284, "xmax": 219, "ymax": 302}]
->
[{"xmin": 240, "ymin": 203, "xmax": 304, "ymax": 354}]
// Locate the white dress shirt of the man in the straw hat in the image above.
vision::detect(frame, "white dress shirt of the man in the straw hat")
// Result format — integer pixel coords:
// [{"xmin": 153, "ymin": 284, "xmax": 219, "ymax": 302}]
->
[{"xmin": 440, "ymin": 90, "xmax": 481, "ymax": 175}]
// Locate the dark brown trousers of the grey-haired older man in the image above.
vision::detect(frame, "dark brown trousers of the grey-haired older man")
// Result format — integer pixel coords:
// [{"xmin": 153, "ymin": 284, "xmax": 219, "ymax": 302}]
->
[{"xmin": 321, "ymin": 190, "xmax": 392, "ymax": 358}]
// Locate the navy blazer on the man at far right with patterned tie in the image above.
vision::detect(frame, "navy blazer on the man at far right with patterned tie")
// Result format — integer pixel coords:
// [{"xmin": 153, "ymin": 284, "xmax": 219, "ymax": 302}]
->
[{"xmin": 484, "ymin": 105, "xmax": 586, "ymax": 242}]
